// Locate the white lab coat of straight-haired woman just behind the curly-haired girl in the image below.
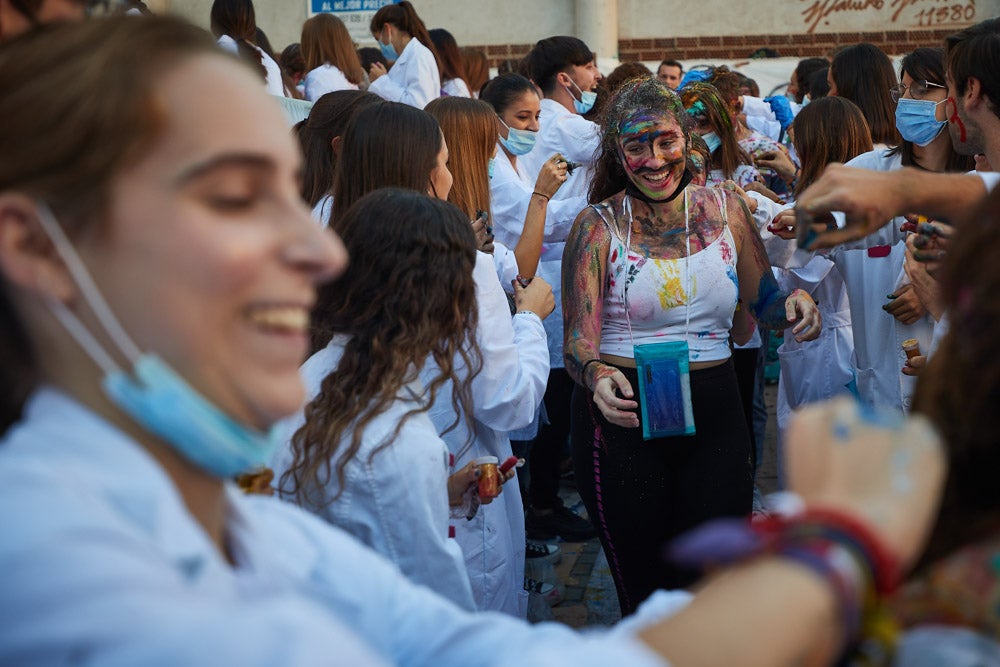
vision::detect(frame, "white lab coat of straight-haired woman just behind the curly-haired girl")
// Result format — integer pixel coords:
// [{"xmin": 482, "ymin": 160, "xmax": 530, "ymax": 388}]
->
[{"xmin": 421, "ymin": 252, "xmax": 551, "ymax": 618}]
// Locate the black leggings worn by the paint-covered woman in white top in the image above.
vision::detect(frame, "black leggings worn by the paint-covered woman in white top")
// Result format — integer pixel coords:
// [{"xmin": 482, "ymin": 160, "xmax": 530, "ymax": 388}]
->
[{"xmin": 571, "ymin": 360, "xmax": 753, "ymax": 615}]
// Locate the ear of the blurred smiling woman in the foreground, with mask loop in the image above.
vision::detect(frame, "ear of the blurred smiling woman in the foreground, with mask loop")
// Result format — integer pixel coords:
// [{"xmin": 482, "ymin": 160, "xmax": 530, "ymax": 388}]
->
[{"xmin": 0, "ymin": 192, "xmax": 76, "ymax": 304}]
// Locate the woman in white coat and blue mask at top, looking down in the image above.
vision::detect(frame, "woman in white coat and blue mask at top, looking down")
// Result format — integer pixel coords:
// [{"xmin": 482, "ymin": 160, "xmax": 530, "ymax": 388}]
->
[{"xmin": 368, "ymin": 0, "xmax": 441, "ymax": 109}]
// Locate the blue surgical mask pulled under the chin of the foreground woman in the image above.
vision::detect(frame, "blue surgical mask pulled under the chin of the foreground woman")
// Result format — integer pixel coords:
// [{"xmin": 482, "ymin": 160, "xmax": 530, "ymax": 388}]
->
[{"xmin": 37, "ymin": 202, "xmax": 281, "ymax": 477}]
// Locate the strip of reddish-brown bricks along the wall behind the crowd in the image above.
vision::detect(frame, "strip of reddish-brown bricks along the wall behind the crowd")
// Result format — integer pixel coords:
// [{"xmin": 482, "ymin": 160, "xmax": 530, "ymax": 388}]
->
[{"xmin": 473, "ymin": 28, "xmax": 958, "ymax": 67}]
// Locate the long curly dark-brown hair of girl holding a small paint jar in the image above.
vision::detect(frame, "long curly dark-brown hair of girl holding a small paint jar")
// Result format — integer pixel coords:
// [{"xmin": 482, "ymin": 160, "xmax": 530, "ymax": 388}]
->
[{"xmin": 279, "ymin": 188, "xmax": 482, "ymax": 508}]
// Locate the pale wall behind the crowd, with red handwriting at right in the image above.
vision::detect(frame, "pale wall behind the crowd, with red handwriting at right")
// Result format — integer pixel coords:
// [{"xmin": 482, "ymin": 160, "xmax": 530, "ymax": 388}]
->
[{"xmin": 165, "ymin": 0, "xmax": 1000, "ymax": 59}]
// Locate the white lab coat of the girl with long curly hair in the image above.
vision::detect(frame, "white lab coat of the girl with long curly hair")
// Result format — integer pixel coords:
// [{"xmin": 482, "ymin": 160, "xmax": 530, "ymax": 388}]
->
[{"xmin": 272, "ymin": 335, "xmax": 476, "ymax": 611}]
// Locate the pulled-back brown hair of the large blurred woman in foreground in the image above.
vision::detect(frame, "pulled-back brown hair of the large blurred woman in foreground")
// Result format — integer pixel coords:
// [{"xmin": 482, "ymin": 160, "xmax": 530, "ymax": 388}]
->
[{"xmin": 0, "ymin": 16, "xmax": 223, "ymax": 433}]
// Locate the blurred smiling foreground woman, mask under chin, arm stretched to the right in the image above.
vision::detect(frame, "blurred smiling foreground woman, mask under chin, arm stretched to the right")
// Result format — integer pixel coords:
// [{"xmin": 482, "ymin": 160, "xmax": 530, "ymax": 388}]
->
[{"xmin": 0, "ymin": 17, "xmax": 941, "ymax": 667}]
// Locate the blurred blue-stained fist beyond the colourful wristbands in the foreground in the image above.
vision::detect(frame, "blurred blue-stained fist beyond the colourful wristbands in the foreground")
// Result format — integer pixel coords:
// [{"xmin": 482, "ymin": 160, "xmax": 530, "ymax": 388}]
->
[{"xmin": 785, "ymin": 398, "xmax": 945, "ymax": 565}]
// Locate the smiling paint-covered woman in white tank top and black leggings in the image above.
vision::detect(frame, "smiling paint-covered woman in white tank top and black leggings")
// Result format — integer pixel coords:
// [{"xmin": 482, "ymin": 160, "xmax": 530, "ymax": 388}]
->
[{"xmin": 563, "ymin": 79, "xmax": 821, "ymax": 613}]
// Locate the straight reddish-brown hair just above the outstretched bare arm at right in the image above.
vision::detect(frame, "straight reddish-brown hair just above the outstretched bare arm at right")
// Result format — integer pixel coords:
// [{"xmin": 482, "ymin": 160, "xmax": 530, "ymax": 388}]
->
[{"xmin": 793, "ymin": 97, "xmax": 873, "ymax": 195}]
